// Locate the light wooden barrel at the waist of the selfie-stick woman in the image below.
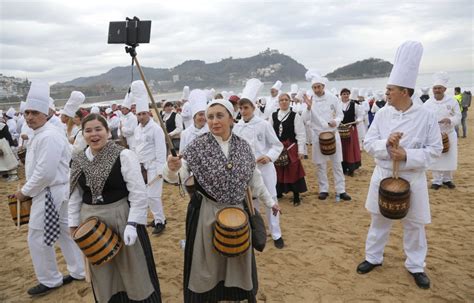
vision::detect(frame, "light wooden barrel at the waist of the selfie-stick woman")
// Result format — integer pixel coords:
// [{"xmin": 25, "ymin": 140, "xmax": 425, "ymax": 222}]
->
[{"xmin": 212, "ymin": 207, "xmax": 250, "ymax": 257}]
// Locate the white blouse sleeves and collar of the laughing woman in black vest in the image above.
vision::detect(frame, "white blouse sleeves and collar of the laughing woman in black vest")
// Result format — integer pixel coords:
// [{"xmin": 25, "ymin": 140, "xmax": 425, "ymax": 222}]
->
[{"xmin": 68, "ymin": 148, "xmax": 148, "ymax": 227}]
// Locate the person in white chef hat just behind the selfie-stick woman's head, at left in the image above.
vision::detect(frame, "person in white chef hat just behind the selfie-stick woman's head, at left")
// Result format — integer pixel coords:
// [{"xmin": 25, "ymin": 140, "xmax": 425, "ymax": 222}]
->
[{"xmin": 179, "ymin": 89, "xmax": 209, "ymax": 154}]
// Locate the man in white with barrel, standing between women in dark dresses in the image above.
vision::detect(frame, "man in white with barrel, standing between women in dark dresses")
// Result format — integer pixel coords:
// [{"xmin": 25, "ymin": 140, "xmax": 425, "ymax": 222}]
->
[{"xmin": 302, "ymin": 73, "xmax": 351, "ymax": 201}]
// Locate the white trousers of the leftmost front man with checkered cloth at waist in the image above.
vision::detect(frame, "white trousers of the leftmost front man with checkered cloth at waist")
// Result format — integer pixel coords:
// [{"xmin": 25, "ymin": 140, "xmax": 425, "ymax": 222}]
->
[{"xmin": 28, "ymin": 223, "xmax": 85, "ymax": 287}]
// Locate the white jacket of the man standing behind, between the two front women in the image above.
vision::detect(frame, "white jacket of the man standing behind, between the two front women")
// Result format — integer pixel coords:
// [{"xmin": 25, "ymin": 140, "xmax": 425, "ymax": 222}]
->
[{"xmin": 134, "ymin": 118, "xmax": 166, "ymax": 175}]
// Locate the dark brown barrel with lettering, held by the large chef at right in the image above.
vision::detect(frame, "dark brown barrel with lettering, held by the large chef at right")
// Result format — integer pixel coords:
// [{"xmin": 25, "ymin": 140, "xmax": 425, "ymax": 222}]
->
[{"xmin": 379, "ymin": 177, "xmax": 410, "ymax": 219}]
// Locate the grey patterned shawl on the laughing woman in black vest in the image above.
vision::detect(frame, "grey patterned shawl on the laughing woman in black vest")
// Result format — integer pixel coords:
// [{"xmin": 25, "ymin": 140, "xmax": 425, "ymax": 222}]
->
[{"xmin": 69, "ymin": 141, "xmax": 124, "ymax": 204}]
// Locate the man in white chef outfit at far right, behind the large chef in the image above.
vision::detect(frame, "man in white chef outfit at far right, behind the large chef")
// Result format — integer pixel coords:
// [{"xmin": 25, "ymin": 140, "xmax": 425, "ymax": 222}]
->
[{"xmin": 424, "ymin": 72, "xmax": 461, "ymax": 190}]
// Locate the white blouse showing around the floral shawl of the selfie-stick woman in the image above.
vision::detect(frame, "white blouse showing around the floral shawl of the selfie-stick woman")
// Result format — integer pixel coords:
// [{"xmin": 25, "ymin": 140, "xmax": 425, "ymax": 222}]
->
[{"xmin": 163, "ymin": 135, "xmax": 276, "ymax": 208}]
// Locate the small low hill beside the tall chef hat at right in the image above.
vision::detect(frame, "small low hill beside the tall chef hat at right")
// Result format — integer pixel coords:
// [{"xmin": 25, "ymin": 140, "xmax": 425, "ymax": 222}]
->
[{"xmin": 326, "ymin": 58, "xmax": 393, "ymax": 80}]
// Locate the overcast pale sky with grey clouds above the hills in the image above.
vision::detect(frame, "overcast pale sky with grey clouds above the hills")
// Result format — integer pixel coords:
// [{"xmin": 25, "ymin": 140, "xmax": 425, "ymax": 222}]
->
[{"xmin": 0, "ymin": 0, "xmax": 474, "ymax": 83}]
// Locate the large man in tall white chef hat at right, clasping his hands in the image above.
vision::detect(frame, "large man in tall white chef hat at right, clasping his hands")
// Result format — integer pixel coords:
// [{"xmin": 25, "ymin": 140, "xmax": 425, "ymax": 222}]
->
[{"xmin": 357, "ymin": 41, "xmax": 442, "ymax": 289}]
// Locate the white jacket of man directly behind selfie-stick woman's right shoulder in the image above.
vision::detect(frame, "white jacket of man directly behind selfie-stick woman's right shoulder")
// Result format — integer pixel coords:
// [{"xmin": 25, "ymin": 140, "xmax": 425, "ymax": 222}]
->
[{"xmin": 232, "ymin": 114, "xmax": 283, "ymax": 162}]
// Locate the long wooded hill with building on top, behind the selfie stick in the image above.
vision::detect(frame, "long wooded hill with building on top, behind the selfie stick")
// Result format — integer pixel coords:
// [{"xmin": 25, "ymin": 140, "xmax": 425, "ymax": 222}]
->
[{"xmin": 53, "ymin": 49, "xmax": 306, "ymax": 92}]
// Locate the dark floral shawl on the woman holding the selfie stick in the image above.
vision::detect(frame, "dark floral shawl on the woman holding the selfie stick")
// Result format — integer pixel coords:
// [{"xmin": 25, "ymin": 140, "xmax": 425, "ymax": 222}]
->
[{"xmin": 183, "ymin": 133, "xmax": 255, "ymax": 205}]
